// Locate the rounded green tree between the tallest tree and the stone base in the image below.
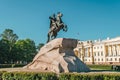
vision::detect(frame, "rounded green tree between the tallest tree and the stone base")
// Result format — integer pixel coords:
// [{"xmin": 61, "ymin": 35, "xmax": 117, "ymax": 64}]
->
[{"xmin": 16, "ymin": 39, "xmax": 36, "ymax": 62}]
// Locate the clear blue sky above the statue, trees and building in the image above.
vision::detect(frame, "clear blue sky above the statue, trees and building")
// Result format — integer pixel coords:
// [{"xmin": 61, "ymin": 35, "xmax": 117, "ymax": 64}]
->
[{"xmin": 0, "ymin": 0, "xmax": 120, "ymax": 44}]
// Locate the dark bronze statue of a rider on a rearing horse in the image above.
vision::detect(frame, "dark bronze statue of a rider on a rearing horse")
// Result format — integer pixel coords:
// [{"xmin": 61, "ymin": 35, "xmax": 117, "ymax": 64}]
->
[{"xmin": 47, "ymin": 12, "xmax": 68, "ymax": 42}]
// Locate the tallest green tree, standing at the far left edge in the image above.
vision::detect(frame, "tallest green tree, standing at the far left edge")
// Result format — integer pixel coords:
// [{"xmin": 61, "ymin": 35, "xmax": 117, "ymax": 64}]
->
[{"xmin": 0, "ymin": 29, "xmax": 18, "ymax": 63}]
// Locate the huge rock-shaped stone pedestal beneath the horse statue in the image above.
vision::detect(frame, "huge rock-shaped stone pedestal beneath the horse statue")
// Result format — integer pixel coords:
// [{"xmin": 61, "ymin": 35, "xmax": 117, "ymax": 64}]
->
[{"xmin": 26, "ymin": 38, "xmax": 90, "ymax": 73}]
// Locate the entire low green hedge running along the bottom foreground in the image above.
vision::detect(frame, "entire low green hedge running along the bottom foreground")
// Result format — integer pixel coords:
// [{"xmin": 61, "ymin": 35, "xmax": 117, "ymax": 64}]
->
[{"xmin": 0, "ymin": 72, "xmax": 120, "ymax": 80}]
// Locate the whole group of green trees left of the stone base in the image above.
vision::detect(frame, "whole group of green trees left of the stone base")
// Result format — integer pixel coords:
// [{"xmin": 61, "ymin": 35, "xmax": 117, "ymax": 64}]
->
[{"xmin": 0, "ymin": 29, "xmax": 44, "ymax": 64}]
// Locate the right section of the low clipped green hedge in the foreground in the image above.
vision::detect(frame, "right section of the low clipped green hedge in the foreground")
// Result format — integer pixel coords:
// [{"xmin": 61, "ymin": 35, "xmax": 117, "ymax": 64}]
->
[{"xmin": 59, "ymin": 73, "xmax": 120, "ymax": 80}]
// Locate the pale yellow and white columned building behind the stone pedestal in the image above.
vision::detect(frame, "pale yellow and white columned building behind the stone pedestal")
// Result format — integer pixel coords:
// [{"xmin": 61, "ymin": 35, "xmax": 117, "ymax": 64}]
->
[{"xmin": 75, "ymin": 37, "xmax": 120, "ymax": 64}]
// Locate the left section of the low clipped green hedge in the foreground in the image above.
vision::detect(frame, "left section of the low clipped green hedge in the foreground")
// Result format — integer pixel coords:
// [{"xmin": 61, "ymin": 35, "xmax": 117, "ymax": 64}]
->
[{"xmin": 2, "ymin": 72, "xmax": 57, "ymax": 80}]
